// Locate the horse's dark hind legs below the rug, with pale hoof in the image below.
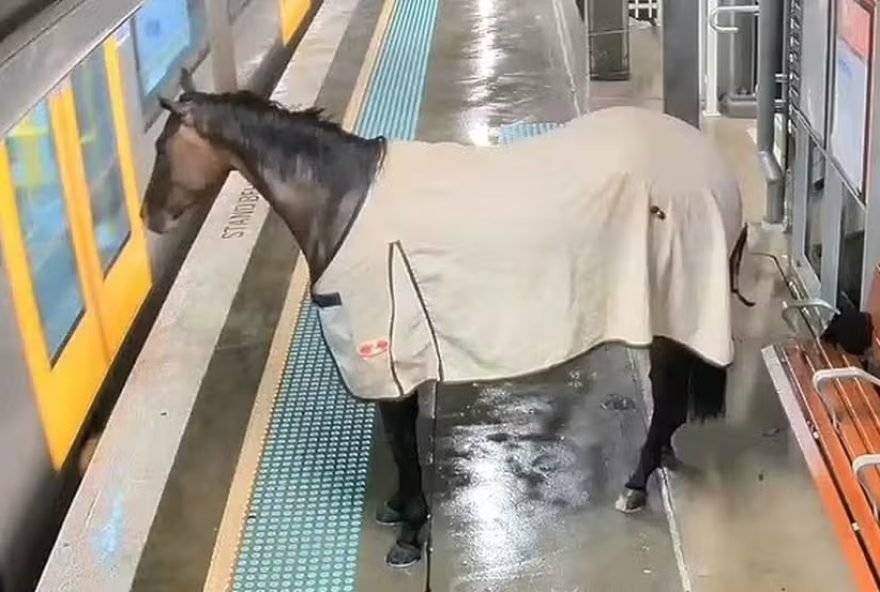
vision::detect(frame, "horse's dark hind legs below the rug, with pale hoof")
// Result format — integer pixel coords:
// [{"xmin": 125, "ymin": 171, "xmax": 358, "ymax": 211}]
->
[{"xmin": 615, "ymin": 338, "xmax": 693, "ymax": 512}]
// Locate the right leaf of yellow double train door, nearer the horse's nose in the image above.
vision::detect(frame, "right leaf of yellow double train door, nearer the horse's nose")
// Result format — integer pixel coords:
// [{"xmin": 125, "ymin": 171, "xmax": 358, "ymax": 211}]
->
[{"xmin": 63, "ymin": 39, "xmax": 150, "ymax": 360}]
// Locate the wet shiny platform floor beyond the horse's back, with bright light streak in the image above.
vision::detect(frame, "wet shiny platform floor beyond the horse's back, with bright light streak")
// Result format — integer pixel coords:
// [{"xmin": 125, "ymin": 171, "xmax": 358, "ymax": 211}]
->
[{"xmin": 418, "ymin": 0, "xmax": 577, "ymax": 145}]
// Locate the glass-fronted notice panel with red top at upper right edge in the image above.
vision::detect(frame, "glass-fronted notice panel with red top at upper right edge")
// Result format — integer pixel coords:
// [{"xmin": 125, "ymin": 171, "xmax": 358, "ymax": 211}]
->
[{"xmin": 831, "ymin": 0, "xmax": 871, "ymax": 192}]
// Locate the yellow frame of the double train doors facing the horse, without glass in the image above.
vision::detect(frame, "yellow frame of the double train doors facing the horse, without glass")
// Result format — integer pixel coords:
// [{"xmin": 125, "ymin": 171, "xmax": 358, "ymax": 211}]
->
[{"xmin": 0, "ymin": 37, "xmax": 152, "ymax": 468}]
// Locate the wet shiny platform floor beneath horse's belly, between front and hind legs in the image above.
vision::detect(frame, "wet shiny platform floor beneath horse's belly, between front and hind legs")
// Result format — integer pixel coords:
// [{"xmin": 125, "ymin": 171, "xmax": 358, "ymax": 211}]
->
[{"xmin": 431, "ymin": 346, "xmax": 678, "ymax": 592}]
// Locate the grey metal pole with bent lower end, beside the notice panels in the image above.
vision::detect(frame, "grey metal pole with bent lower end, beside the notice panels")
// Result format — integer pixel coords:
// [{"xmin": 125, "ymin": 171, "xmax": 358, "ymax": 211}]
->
[{"xmin": 757, "ymin": 0, "xmax": 785, "ymax": 224}]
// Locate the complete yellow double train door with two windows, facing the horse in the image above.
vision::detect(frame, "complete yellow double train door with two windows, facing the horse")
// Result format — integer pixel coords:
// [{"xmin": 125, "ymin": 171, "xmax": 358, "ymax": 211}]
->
[{"xmin": 0, "ymin": 39, "xmax": 151, "ymax": 467}]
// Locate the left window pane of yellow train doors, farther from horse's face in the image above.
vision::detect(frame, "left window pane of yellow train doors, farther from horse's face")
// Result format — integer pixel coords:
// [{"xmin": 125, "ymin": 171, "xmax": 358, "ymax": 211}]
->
[{"xmin": 6, "ymin": 103, "xmax": 85, "ymax": 360}]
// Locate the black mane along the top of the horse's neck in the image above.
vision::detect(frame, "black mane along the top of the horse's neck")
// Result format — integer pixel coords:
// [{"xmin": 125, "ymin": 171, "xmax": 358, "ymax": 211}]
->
[{"xmin": 180, "ymin": 91, "xmax": 387, "ymax": 176}]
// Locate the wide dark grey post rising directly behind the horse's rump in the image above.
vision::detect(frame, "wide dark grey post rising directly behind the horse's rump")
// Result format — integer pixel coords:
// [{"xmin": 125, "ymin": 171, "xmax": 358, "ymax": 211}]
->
[{"xmin": 662, "ymin": 0, "xmax": 700, "ymax": 128}]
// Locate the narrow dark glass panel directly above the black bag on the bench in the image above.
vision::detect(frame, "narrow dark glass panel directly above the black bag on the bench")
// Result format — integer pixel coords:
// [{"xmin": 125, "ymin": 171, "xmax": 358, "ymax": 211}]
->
[{"xmin": 837, "ymin": 189, "xmax": 865, "ymax": 308}]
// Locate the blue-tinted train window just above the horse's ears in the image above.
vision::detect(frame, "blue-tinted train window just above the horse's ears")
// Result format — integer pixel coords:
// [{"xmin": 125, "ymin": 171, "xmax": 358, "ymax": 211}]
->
[{"xmin": 134, "ymin": 0, "xmax": 207, "ymax": 121}]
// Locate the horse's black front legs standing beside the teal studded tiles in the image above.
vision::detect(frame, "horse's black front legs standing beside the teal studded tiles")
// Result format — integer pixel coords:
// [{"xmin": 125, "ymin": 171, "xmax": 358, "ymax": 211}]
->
[{"xmin": 376, "ymin": 394, "xmax": 428, "ymax": 567}]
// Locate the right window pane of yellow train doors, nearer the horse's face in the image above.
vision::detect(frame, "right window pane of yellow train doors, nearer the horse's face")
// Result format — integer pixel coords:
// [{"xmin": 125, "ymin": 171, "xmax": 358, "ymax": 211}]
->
[{"xmin": 73, "ymin": 50, "xmax": 131, "ymax": 275}]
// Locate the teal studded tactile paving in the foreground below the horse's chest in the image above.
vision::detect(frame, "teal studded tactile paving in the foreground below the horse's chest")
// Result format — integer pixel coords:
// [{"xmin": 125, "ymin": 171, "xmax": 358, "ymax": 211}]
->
[{"xmin": 232, "ymin": 301, "xmax": 374, "ymax": 592}]
